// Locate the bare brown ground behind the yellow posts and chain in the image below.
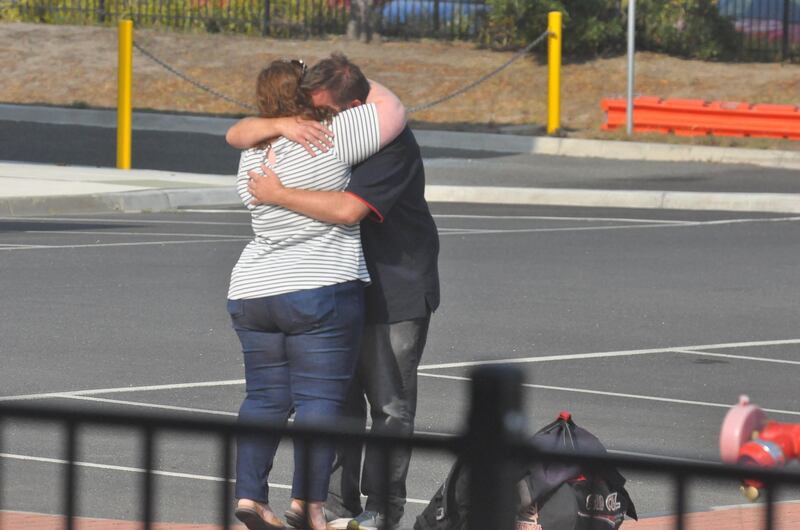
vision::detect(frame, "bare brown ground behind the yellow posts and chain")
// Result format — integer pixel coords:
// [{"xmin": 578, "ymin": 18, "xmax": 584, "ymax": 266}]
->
[{"xmin": 0, "ymin": 22, "xmax": 800, "ymax": 149}]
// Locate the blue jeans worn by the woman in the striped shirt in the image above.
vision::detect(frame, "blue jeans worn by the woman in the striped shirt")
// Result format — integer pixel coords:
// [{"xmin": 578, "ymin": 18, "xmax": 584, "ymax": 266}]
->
[{"xmin": 228, "ymin": 280, "xmax": 364, "ymax": 502}]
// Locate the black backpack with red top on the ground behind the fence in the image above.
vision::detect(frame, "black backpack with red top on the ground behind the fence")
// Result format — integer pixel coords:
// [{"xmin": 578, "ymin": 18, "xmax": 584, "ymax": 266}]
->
[{"xmin": 414, "ymin": 412, "xmax": 637, "ymax": 530}]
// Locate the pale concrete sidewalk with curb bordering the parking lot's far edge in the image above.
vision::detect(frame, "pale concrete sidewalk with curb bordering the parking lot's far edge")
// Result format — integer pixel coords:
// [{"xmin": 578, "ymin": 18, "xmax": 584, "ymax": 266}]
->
[{"xmin": 0, "ymin": 158, "xmax": 800, "ymax": 216}]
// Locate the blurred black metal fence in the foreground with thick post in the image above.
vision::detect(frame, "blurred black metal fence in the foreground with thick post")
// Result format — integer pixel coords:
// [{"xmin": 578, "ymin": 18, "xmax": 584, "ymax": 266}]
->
[{"xmin": 0, "ymin": 367, "xmax": 800, "ymax": 530}]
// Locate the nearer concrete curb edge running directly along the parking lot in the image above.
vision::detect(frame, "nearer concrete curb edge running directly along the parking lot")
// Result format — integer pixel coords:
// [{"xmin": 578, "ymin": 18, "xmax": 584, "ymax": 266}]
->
[{"xmin": 0, "ymin": 185, "xmax": 800, "ymax": 217}]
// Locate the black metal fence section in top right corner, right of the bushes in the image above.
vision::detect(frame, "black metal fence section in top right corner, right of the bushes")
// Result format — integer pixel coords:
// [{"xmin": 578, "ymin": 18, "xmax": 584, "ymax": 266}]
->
[{"xmin": 719, "ymin": 0, "xmax": 800, "ymax": 60}]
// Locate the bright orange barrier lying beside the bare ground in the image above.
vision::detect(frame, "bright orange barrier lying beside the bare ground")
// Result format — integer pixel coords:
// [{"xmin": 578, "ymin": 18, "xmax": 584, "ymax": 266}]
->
[{"xmin": 600, "ymin": 96, "xmax": 800, "ymax": 140}]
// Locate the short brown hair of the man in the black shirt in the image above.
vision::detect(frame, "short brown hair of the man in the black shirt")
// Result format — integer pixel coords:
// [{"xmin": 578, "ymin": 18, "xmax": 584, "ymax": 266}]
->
[{"xmin": 303, "ymin": 53, "xmax": 369, "ymax": 110}]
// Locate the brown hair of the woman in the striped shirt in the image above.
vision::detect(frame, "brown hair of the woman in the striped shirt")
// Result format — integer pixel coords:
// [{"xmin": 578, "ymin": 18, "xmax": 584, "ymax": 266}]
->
[{"xmin": 256, "ymin": 60, "xmax": 332, "ymax": 121}]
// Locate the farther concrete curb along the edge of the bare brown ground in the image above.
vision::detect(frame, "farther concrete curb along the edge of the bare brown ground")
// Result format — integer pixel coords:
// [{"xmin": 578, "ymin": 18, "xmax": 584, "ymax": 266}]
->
[{"xmin": 6, "ymin": 104, "xmax": 800, "ymax": 170}]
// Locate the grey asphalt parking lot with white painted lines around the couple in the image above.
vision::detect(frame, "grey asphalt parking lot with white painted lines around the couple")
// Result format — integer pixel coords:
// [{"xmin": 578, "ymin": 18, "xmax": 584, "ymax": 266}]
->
[{"xmin": 0, "ymin": 204, "xmax": 800, "ymax": 527}]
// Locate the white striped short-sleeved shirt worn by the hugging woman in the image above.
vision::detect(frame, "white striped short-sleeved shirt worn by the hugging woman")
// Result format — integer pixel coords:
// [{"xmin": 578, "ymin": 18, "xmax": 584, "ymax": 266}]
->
[{"xmin": 228, "ymin": 104, "xmax": 380, "ymax": 300}]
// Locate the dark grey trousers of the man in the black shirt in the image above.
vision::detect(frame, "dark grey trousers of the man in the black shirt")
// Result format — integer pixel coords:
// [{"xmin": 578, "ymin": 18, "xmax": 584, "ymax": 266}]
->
[{"xmin": 327, "ymin": 315, "xmax": 430, "ymax": 524}]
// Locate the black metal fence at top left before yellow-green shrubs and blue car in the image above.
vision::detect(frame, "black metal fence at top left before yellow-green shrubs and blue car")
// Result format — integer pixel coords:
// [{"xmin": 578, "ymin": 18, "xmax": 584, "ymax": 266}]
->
[{"xmin": 0, "ymin": 0, "xmax": 486, "ymax": 39}]
